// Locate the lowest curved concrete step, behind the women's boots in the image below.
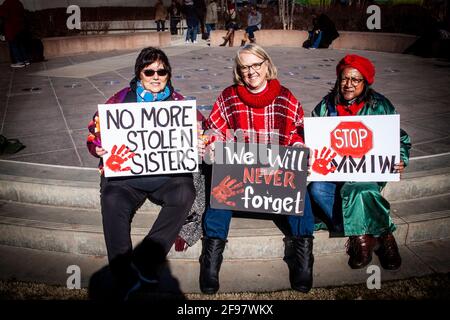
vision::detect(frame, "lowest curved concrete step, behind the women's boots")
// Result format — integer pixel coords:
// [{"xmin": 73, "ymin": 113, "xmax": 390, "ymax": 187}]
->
[{"xmin": 0, "ymin": 239, "xmax": 450, "ymax": 293}]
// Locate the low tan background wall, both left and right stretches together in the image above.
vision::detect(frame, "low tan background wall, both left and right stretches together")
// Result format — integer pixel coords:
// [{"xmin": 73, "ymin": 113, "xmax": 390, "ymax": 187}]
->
[{"xmin": 0, "ymin": 29, "xmax": 417, "ymax": 63}]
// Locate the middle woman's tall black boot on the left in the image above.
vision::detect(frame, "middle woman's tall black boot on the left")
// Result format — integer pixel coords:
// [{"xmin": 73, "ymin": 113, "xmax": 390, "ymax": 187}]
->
[{"xmin": 200, "ymin": 238, "xmax": 227, "ymax": 294}]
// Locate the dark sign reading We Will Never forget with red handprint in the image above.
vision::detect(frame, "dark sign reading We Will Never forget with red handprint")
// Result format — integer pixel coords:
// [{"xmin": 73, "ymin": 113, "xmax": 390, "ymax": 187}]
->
[{"xmin": 210, "ymin": 142, "xmax": 309, "ymax": 215}]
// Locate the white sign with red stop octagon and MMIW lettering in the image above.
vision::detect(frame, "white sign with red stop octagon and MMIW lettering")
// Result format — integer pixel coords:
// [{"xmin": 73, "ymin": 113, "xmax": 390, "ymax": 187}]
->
[{"xmin": 305, "ymin": 115, "xmax": 401, "ymax": 181}]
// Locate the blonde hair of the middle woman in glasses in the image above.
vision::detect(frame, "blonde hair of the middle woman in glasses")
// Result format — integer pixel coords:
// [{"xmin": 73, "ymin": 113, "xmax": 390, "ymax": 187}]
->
[{"xmin": 233, "ymin": 43, "xmax": 278, "ymax": 86}]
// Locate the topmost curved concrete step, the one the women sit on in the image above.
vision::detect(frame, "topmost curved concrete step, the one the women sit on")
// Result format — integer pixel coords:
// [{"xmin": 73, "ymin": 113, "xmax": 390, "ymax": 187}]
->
[{"xmin": 0, "ymin": 154, "xmax": 450, "ymax": 212}]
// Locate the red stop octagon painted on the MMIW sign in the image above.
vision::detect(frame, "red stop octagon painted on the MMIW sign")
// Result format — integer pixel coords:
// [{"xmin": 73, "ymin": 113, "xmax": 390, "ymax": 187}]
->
[{"xmin": 331, "ymin": 121, "xmax": 373, "ymax": 158}]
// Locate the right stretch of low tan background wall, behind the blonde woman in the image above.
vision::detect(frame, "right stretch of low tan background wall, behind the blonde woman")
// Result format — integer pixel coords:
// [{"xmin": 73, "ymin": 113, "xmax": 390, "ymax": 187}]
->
[{"xmin": 211, "ymin": 29, "xmax": 417, "ymax": 53}]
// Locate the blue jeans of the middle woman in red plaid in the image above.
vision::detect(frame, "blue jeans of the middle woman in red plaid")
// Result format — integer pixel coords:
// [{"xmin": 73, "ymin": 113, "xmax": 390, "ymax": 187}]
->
[{"xmin": 203, "ymin": 192, "xmax": 314, "ymax": 240}]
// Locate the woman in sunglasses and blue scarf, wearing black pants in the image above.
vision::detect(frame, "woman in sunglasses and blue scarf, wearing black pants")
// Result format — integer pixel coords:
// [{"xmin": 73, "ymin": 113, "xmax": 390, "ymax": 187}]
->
[{"xmin": 87, "ymin": 47, "xmax": 204, "ymax": 300}]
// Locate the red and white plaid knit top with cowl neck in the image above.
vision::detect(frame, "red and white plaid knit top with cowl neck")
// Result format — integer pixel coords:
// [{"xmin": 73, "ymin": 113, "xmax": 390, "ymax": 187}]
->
[{"xmin": 205, "ymin": 80, "xmax": 304, "ymax": 146}]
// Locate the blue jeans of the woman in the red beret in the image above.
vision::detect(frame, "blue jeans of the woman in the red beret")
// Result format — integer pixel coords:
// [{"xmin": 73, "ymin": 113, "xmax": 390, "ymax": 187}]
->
[{"xmin": 308, "ymin": 182, "xmax": 344, "ymax": 232}]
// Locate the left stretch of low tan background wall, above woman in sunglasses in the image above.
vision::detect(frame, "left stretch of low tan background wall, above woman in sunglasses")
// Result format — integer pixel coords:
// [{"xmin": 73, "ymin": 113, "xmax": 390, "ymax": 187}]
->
[{"xmin": 42, "ymin": 31, "xmax": 171, "ymax": 59}]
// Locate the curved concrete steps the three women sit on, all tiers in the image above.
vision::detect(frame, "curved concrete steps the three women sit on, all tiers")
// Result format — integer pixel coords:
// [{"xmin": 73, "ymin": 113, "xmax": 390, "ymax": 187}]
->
[{"xmin": 0, "ymin": 155, "xmax": 450, "ymax": 292}]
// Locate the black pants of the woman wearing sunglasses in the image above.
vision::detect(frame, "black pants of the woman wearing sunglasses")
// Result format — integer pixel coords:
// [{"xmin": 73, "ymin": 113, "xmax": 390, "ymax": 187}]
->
[{"xmin": 100, "ymin": 175, "xmax": 195, "ymax": 273}]
